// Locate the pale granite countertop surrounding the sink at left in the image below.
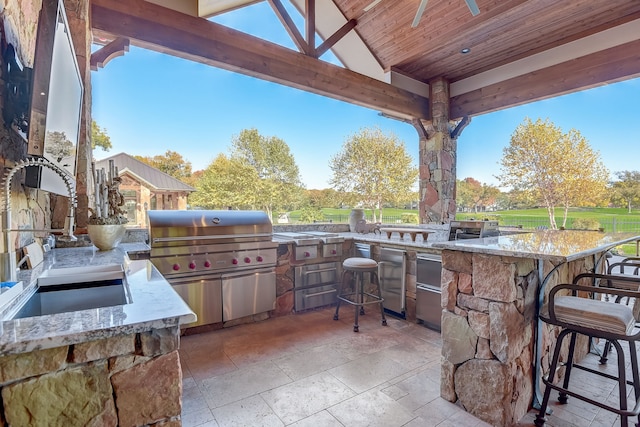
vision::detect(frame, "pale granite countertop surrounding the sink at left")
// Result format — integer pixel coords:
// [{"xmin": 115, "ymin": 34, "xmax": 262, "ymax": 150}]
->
[{"xmin": 0, "ymin": 243, "xmax": 196, "ymax": 356}]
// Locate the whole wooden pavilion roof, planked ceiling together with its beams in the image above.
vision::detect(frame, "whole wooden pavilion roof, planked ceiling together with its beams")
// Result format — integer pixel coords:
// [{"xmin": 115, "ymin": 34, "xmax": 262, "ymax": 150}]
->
[{"xmin": 91, "ymin": 0, "xmax": 640, "ymax": 119}]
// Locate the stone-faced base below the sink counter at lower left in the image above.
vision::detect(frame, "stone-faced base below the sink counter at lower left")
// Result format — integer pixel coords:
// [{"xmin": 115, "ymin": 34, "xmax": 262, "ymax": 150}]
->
[{"xmin": 0, "ymin": 327, "xmax": 182, "ymax": 426}]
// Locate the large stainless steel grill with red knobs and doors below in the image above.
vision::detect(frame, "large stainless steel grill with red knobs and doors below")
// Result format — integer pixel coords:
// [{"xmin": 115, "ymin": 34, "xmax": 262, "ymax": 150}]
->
[{"xmin": 148, "ymin": 210, "xmax": 278, "ymax": 327}]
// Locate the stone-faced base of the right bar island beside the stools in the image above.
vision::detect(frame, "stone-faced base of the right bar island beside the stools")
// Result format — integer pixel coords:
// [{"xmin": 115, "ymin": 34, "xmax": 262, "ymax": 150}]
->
[{"xmin": 440, "ymin": 250, "xmax": 594, "ymax": 426}]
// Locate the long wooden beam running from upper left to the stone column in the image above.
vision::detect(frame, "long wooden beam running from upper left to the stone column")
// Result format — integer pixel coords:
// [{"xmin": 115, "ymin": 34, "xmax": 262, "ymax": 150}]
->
[{"xmin": 91, "ymin": 0, "xmax": 429, "ymax": 119}]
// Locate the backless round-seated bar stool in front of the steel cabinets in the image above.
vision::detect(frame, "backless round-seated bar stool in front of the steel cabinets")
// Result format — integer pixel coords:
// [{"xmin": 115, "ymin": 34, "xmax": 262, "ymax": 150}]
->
[{"xmin": 333, "ymin": 257, "xmax": 387, "ymax": 332}]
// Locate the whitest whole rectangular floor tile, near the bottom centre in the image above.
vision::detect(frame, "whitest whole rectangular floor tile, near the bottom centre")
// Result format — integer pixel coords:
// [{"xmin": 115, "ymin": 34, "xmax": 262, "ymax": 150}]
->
[{"xmin": 261, "ymin": 372, "xmax": 355, "ymax": 424}]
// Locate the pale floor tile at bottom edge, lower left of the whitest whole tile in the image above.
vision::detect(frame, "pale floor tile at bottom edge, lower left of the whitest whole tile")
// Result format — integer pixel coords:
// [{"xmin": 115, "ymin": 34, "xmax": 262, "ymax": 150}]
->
[{"xmin": 212, "ymin": 396, "xmax": 284, "ymax": 427}]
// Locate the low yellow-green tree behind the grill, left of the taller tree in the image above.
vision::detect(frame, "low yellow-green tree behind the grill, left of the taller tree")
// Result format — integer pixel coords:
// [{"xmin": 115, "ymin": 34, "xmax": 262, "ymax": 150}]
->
[{"xmin": 189, "ymin": 154, "xmax": 259, "ymax": 209}]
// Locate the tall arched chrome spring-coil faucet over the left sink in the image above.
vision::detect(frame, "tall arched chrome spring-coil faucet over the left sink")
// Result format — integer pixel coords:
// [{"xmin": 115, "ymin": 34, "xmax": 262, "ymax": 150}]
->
[{"xmin": 0, "ymin": 157, "xmax": 78, "ymax": 282}]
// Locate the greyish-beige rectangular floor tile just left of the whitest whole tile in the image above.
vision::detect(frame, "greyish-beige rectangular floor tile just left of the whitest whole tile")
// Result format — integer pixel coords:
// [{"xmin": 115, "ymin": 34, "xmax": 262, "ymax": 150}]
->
[{"xmin": 202, "ymin": 362, "xmax": 291, "ymax": 409}]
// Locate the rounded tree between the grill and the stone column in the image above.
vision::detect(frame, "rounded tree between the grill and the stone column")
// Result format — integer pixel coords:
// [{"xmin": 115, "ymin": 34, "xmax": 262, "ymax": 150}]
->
[{"xmin": 329, "ymin": 128, "xmax": 418, "ymax": 221}]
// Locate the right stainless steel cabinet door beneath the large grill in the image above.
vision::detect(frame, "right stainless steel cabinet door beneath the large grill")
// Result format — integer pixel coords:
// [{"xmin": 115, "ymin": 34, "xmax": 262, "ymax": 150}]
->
[{"xmin": 222, "ymin": 267, "xmax": 276, "ymax": 322}]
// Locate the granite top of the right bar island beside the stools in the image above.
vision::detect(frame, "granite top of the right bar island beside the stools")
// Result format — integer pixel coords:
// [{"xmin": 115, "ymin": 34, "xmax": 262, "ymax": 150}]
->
[{"xmin": 433, "ymin": 230, "xmax": 640, "ymax": 262}]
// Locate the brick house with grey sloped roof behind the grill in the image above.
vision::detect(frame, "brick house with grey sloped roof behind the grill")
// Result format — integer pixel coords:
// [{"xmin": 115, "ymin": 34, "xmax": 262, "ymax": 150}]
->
[{"xmin": 96, "ymin": 153, "xmax": 196, "ymax": 227}]
